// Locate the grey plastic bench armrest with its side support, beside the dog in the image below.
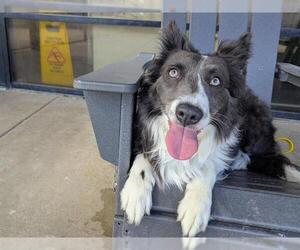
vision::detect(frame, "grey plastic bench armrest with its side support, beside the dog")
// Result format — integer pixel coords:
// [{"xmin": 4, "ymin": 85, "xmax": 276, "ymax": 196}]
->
[{"xmin": 74, "ymin": 53, "xmax": 154, "ymax": 169}]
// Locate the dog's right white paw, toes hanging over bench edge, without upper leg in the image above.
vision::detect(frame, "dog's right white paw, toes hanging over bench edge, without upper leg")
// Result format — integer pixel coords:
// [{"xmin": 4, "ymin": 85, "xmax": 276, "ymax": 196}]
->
[{"xmin": 177, "ymin": 190, "xmax": 211, "ymax": 237}]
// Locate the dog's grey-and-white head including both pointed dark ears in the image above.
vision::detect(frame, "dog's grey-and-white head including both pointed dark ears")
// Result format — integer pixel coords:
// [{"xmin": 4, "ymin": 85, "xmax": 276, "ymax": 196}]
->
[{"xmin": 150, "ymin": 23, "xmax": 250, "ymax": 139}]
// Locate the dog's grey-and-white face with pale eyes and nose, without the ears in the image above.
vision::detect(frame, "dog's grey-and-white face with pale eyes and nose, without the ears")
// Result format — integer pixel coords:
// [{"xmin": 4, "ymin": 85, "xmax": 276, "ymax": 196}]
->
[{"xmin": 156, "ymin": 50, "xmax": 231, "ymax": 130}]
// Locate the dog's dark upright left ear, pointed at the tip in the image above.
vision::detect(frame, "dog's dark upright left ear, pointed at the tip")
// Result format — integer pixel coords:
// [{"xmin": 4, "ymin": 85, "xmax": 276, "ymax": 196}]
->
[{"xmin": 160, "ymin": 21, "xmax": 198, "ymax": 55}]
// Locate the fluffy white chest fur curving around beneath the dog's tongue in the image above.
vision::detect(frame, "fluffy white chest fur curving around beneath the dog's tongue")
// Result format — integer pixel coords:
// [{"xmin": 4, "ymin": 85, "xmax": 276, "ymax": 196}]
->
[{"xmin": 149, "ymin": 115, "xmax": 244, "ymax": 187}]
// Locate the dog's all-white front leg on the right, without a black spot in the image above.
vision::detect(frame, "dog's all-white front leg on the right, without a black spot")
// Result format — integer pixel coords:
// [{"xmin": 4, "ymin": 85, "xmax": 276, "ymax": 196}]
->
[{"xmin": 177, "ymin": 167, "xmax": 216, "ymax": 237}]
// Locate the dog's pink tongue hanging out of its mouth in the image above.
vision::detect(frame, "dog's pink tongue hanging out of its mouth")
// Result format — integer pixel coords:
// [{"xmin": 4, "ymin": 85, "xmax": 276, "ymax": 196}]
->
[{"xmin": 166, "ymin": 122, "xmax": 198, "ymax": 160}]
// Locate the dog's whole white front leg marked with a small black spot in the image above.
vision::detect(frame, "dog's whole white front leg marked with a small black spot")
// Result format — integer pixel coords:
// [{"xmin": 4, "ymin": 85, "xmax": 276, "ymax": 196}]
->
[{"xmin": 121, "ymin": 154, "xmax": 155, "ymax": 225}]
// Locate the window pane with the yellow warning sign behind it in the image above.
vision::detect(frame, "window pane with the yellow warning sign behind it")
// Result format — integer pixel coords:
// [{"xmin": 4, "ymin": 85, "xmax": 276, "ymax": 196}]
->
[{"xmin": 7, "ymin": 19, "xmax": 159, "ymax": 87}]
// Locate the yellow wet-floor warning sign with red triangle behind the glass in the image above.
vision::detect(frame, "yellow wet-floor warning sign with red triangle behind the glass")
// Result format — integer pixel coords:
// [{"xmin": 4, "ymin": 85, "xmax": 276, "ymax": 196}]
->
[{"xmin": 39, "ymin": 21, "xmax": 74, "ymax": 86}]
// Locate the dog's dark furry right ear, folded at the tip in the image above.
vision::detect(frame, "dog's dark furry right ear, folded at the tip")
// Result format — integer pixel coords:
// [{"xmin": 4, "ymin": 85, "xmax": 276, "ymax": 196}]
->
[{"xmin": 217, "ymin": 32, "xmax": 251, "ymax": 73}]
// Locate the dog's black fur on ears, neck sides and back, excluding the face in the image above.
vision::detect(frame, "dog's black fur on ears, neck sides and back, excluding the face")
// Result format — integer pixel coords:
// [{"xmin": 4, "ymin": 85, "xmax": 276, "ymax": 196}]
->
[{"xmin": 133, "ymin": 23, "xmax": 290, "ymax": 178}]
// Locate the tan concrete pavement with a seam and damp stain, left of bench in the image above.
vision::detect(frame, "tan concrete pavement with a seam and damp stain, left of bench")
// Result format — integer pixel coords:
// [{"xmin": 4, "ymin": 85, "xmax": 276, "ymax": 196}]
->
[{"xmin": 0, "ymin": 90, "xmax": 114, "ymax": 237}]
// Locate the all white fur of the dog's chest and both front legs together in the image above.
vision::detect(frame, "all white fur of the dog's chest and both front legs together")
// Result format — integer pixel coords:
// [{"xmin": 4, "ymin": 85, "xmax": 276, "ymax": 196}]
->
[{"xmin": 121, "ymin": 113, "xmax": 248, "ymax": 236}]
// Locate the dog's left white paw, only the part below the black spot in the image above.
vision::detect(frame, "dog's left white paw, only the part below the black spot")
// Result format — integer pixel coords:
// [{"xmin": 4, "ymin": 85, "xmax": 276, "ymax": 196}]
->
[{"xmin": 121, "ymin": 175, "xmax": 153, "ymax": 225}]
